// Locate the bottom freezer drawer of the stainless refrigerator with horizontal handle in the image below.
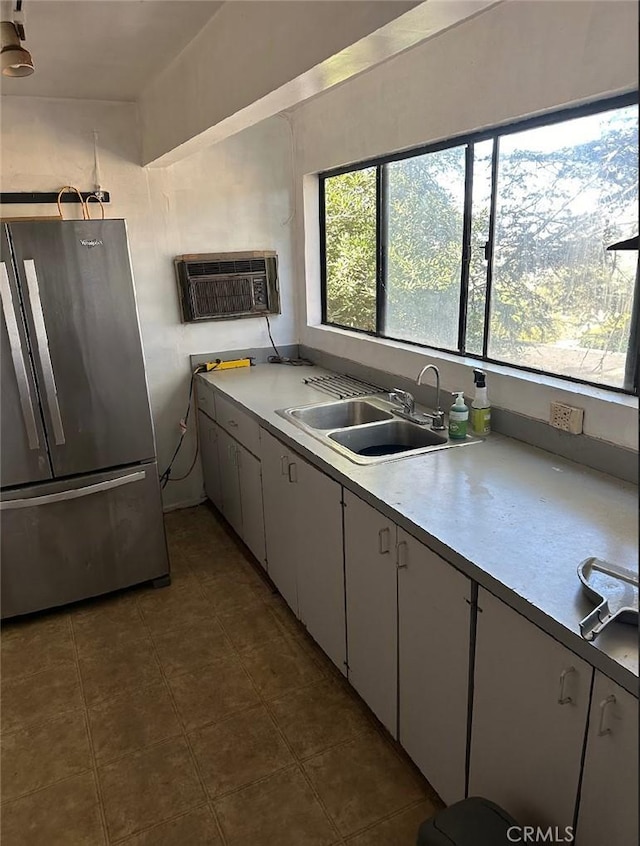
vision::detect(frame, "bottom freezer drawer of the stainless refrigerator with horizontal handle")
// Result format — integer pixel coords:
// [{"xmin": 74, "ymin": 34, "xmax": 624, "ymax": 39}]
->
[{"xmin": 0, "ymin": 463, "xmax": 169, "ymax": 618}]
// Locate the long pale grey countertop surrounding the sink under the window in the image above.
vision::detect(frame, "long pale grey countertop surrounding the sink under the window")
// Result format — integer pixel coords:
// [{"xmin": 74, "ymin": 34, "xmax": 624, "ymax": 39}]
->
[{"xmin": 201, "ymin": 364, "xmax": 638, "ymax": 696}]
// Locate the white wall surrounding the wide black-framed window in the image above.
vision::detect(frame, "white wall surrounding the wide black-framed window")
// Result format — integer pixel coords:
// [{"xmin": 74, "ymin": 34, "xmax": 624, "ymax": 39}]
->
[{"xmin": 293, "ymin": 0, "xmax": 638, "ymax": 448}]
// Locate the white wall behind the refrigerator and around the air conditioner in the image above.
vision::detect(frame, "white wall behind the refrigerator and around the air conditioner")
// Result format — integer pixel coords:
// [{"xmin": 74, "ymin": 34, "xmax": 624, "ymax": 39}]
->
[{"xmin": 0, "ymin": 97, "xmax": 296, "ymax": 506}]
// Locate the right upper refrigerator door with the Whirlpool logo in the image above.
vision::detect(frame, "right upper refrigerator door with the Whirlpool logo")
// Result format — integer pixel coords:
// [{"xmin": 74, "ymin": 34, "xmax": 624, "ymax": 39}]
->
[{"xmin": 9, "ymin": 220, "xmax": 155, "ymax": 478}]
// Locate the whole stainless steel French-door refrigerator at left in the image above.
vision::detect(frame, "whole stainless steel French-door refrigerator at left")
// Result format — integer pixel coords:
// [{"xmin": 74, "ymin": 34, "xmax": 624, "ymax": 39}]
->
[{"xmin": 0, "ymin": 220, "xmax": 169, "ymax": 618}]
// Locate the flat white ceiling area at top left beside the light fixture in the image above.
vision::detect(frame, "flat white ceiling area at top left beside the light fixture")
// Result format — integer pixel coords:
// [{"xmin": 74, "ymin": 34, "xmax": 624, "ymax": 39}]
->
[{"xmin": 0, "ymin": 0, "xmax": 222, "ymax": 100}]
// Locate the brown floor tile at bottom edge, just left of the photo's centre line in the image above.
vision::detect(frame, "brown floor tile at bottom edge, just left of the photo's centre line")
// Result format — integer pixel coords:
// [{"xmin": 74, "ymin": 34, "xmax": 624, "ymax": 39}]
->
[{"xmin": 214, "ymin": 767, "xmax": 338, "ymax": 846}]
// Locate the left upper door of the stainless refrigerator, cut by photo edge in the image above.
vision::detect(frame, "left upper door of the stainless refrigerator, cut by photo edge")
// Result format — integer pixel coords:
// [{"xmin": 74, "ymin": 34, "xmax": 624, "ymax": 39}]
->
[{"xmin": 0, "ymin": 226, "xmax": 51, "ymax": 486}]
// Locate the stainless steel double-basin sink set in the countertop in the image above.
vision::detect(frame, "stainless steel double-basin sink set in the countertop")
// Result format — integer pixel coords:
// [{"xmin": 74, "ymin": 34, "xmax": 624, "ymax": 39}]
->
[{"xmin": 278, "ymin": 396, "xmax": 481, "ymax": 464}]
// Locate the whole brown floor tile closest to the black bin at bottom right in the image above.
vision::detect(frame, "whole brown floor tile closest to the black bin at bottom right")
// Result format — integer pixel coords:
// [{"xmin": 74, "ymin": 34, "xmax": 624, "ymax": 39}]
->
[{"xmin": 303, "ymin": 732, "xmax": 425, "ymax": 836}]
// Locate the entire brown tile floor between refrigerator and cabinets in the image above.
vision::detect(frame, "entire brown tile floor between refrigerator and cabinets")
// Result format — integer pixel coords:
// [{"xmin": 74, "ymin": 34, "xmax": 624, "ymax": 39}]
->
[{"xmin": 0, "ymin": 505, "xmax": 440, "ymax": 846}]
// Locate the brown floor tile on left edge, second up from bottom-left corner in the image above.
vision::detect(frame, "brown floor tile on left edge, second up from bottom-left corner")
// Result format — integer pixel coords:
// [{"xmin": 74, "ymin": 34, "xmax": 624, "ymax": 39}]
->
[{"xmin": 0, "ymin": 711, "xmax": 93, "ymax": 801}]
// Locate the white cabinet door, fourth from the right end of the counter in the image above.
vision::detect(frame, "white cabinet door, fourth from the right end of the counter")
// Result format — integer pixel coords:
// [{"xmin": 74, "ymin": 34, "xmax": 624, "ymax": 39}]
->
[{"xmin": 344, "ymin": 491, "xmax": 398, "ymax": 737}]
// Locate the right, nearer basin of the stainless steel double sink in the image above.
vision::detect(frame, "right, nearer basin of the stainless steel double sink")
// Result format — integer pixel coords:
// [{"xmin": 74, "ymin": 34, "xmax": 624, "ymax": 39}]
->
[{"xmin": 329, "ymin": 420, "xmax": 449, "ymax": 456}]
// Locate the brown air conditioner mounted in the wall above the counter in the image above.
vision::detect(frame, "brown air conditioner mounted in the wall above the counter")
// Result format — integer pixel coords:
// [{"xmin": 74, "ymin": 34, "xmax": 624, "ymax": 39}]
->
[{"xmin": 175, "ymin": 250, "xmax": 280, "ymax": 323}]
